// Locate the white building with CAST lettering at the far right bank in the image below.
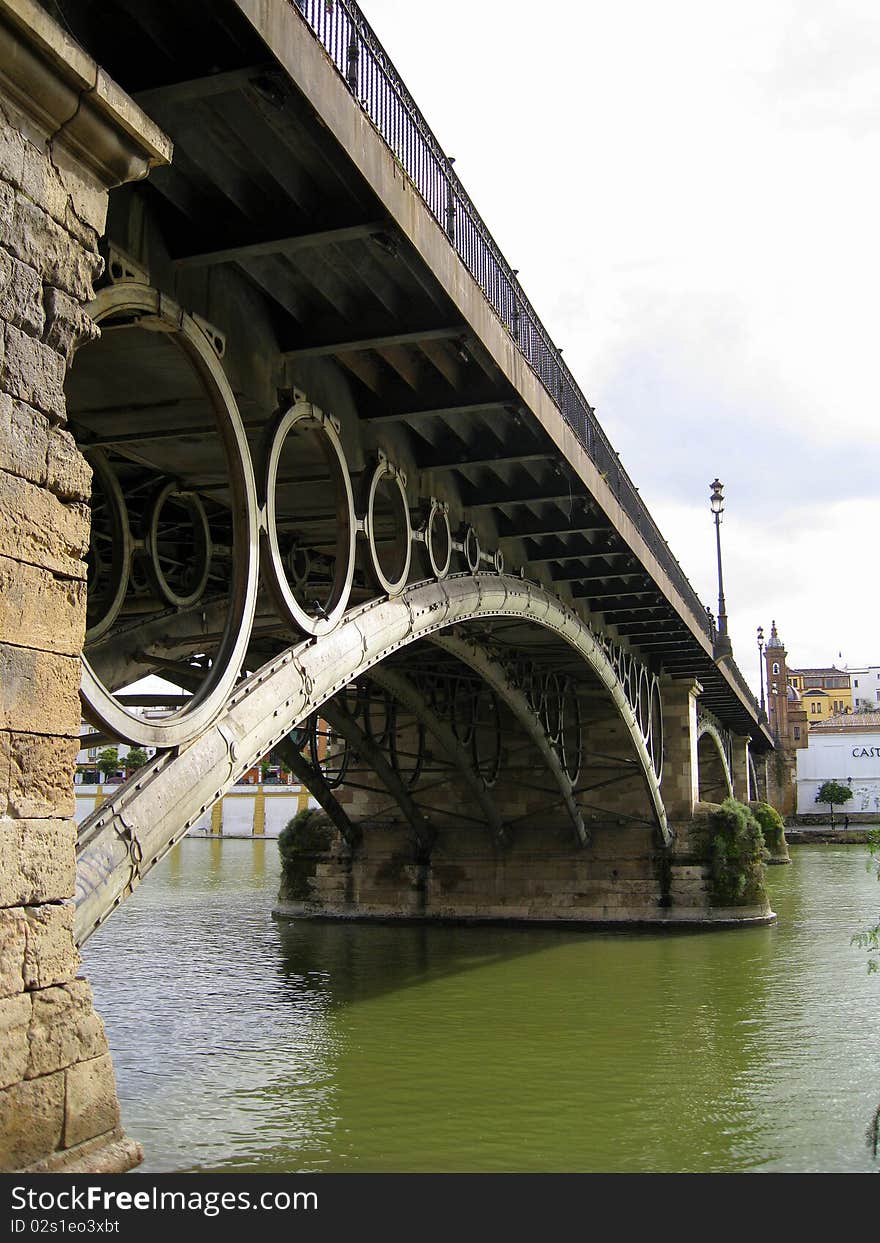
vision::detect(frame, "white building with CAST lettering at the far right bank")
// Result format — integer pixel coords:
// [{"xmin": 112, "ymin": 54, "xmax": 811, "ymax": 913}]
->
[{"xmin": 797, "ymin": 710, "xmax": 880, "ymax": 815}]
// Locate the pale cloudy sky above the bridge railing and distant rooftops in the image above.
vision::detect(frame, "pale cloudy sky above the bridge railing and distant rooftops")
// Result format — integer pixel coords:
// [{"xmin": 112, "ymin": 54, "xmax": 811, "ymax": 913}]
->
[{"xmin": 362, "ymin": 0, "xmax": 880, "ymax": 690}]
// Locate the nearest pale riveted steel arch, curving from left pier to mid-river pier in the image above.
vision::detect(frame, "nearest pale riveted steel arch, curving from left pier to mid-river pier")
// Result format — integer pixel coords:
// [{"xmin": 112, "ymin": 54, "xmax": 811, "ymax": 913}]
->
[{"xmin": 76, "ymin": 573, "xmax": 671, "ymax": 943}]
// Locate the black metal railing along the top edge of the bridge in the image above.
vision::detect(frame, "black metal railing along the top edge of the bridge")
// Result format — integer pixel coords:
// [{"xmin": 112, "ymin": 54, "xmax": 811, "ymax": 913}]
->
[{"xmin": 290, "ymin": 0, "xmax": 754, "ymax": 686}]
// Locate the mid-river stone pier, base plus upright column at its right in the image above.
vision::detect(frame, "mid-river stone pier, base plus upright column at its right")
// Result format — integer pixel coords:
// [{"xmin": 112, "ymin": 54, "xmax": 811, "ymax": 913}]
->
[{"xmin": 276, "ymin": 679, "xmax": 773, "ymax": 925}]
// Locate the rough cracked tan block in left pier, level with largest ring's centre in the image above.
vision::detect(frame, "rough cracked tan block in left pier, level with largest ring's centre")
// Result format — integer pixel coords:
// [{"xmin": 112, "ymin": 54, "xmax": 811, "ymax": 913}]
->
[{"xmin": 0, "ymin": 471, "xmax": 89, "ymax": 579}]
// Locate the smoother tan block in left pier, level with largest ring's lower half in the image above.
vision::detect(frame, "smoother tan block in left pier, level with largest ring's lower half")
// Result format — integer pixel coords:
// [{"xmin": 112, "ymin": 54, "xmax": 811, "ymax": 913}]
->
[{"xmin": 0, "ymin": 557, "xmax": 86, "ymax": 656}]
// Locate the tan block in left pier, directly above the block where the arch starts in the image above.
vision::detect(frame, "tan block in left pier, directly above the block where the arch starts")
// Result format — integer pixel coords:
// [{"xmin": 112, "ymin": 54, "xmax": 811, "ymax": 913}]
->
[{"xmin": 0, "ymin": 731, "xmax": 80, "ymax": 819}]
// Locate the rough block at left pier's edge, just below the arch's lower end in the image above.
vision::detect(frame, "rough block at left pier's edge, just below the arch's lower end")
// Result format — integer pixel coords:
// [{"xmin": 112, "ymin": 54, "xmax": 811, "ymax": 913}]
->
[{"xmin": 25, "ymin": 979, "xmax": 108, "ymax": 1079}]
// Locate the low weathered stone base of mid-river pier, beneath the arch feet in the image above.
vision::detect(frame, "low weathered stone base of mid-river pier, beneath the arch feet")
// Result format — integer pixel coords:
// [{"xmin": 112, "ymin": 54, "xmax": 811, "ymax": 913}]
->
[{"xmin": 276, "ymin": 804, "xmax": 772, "ymax": 925}]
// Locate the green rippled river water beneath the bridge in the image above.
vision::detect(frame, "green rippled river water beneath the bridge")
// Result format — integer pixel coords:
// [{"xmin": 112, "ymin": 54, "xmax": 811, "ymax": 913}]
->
[{"xmin": 83, "ymin": 839, "xmax": 880, "ymax": 1172}]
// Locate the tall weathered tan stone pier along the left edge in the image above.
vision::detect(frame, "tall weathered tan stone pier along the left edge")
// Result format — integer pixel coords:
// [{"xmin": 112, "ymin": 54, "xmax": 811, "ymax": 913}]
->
[{"xmin": 0, "ymin": 0, "xmax": 170, "ymax": 1171}]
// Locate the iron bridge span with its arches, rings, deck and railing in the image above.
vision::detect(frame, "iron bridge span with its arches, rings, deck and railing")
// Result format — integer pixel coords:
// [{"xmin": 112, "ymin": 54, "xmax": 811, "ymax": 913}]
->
[{"xmin": 53, "ymin": 0, "xmax": 772, "ymax": 941}]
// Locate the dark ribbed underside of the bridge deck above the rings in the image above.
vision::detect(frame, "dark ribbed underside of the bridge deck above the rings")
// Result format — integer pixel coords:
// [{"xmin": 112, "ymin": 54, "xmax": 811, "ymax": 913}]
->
[{"xmin": 58, "ymin": 0, "xmax": 770, "ymax": 733}]
